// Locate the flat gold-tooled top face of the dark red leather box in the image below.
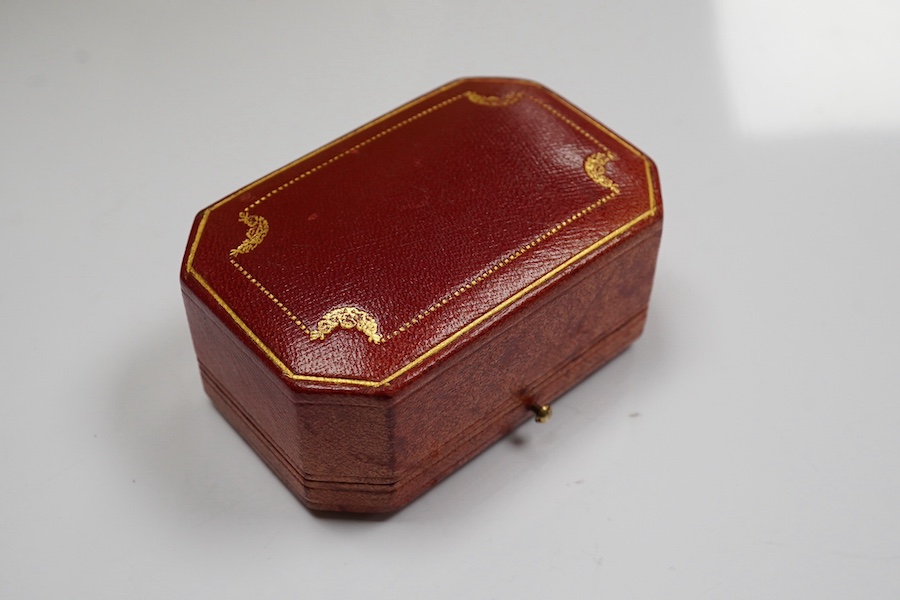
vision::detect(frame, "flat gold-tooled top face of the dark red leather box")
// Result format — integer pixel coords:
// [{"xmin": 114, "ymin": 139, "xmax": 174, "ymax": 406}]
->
[{"xmin": 182, "ymin": 79, "xmax": 661, "ymax": 393}]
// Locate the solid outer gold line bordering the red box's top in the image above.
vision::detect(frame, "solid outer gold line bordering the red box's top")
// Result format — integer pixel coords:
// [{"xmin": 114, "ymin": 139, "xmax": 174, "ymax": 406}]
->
[{"xmin": 185, "ymin": 79, "xmax": 658, "ymax": 387}]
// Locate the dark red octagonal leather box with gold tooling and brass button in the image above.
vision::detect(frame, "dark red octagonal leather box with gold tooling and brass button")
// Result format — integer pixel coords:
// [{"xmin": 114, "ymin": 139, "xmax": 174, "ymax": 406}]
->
[{"xmin": 181, "ymin": 79, "xmax": 662, "ymax": 512}]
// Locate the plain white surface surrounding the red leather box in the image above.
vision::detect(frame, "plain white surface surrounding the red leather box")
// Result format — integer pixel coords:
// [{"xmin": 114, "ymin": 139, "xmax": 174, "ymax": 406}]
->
[{"xmin": 0, "ymin": 0, "xmax": 900, "ymax": 600}]
